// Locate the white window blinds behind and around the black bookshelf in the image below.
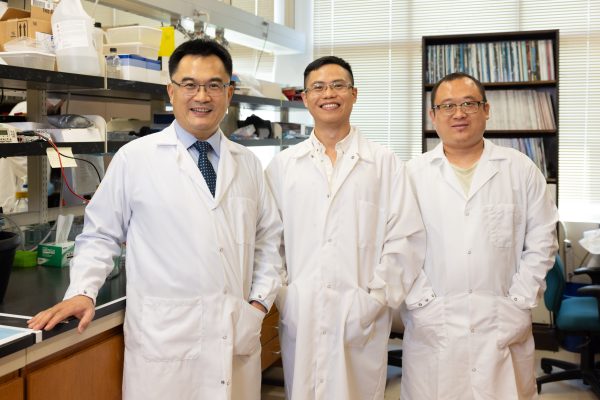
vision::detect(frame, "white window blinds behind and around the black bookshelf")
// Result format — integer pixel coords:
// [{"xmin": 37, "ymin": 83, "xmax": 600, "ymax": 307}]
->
[{"xmin": 313, "ymin": 0, "xmax": 600, "ymax": 222}]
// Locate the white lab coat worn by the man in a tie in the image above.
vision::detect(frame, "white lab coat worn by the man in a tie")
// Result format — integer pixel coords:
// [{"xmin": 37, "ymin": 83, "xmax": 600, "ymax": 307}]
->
[{"xmin": 65, "ymin": 125, "xmax": 281, "ymax": 400}]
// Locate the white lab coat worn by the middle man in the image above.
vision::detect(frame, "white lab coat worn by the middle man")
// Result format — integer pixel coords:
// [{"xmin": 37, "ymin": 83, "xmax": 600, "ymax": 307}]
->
[{"xmin": 267, "ymin": 128, "xmax": 425, "ymax": 400}]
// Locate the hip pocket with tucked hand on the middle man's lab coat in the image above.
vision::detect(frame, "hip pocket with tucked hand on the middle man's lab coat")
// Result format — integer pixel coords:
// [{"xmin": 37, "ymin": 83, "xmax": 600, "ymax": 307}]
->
[{"xmin": 344, "ymin": 288, "xmax": 385, "ymax": 347}]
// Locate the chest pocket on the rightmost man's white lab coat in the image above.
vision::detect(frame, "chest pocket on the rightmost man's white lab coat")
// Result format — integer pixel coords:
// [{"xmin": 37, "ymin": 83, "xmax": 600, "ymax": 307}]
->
[{"xmin": 483, "ymin": 204, "xmax": 522, "ymax": 248}]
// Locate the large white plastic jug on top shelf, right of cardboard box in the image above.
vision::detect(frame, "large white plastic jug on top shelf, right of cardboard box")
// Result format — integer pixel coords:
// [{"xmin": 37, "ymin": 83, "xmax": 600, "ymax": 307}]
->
[{"xmin": 51, "ymin": 0, "xmax": 100, "ymax": 75}]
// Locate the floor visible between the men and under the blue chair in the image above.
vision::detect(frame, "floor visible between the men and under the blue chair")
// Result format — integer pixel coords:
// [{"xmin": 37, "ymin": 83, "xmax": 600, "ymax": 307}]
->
[{"xmin": 262, "ymin": 340, "xmax": 597, "ymax": 400}]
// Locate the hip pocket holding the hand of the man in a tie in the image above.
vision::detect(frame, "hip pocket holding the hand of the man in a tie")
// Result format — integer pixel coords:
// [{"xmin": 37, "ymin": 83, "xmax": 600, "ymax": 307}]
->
[{"xmin": 233, "ymin": 300, "xmax": 266, "ymax": 356}]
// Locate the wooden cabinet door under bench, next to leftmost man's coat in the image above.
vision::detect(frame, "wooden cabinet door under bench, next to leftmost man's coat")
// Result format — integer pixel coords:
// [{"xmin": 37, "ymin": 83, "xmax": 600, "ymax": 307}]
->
[{"xmin": 26, "ymin": 334, "xmax": 124, "ymax": 400}]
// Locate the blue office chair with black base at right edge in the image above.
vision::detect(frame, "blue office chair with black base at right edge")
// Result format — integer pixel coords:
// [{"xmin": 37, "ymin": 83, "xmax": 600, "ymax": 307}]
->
[{"xmin": 537, "ymin": 256, "xmax": 600, "ymax": 398}]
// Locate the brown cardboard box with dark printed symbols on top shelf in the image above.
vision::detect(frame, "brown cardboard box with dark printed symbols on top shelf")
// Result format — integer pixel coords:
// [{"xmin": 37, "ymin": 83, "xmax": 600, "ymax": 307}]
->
[{"xmin": 0, "ymin": 7, "xmax": 52, "ymax": 50}]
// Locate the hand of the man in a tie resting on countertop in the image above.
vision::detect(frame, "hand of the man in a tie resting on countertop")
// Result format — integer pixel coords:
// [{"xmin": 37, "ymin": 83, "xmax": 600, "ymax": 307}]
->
[{"xmin": 27, "ymin": 295, "xmax": 96, "ymax": 333}]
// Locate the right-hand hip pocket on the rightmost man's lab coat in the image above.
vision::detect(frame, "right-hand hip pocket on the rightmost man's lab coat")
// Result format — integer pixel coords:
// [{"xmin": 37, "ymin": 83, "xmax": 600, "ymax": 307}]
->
[{"xmin": 496, "ymin": 297, "xmax": 532, "ymax": 349}]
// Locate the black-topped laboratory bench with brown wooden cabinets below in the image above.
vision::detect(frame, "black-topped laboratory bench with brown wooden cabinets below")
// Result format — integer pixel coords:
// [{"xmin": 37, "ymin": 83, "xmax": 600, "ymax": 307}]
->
[{"xmin": 0, "ymin": 266, "xmax": 280, "ymax": 400}]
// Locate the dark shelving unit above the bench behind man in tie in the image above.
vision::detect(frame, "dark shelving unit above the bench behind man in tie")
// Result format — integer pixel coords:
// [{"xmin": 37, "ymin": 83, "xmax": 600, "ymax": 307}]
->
[{"xmin": 0, "ymin": 65, "xmax": 304, "ymax": 225}]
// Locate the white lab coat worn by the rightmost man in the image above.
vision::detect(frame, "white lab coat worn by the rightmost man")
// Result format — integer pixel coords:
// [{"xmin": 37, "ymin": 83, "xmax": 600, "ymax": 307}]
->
[{"xmin": 401, "ymin": 140, "xmax": 558, "ymax": 400}]
